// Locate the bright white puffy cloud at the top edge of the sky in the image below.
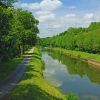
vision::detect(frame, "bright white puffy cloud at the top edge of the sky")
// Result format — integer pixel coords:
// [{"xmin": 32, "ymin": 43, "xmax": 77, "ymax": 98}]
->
[{"xmin": 14, "ymin": 0, "xmax": 62, "ymax": 11}]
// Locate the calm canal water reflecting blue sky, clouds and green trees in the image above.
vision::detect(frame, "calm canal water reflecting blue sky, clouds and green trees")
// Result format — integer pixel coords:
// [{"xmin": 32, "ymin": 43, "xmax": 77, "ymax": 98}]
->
[{"xmin": 42, "ymin": 52, "xmax": 100, "ymax": 100}]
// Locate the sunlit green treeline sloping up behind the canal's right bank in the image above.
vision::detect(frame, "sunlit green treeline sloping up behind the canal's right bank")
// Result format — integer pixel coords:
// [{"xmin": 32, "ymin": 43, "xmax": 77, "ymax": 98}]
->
[{"xmin": 38, "ymin": 22, "xmax": 100, "ymax": 54}]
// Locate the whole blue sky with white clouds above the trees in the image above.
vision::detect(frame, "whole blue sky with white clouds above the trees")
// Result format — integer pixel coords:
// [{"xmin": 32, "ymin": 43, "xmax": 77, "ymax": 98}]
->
[{"xmin": 14, "ymin": 0, "xmax": 100, "ymax": 37}]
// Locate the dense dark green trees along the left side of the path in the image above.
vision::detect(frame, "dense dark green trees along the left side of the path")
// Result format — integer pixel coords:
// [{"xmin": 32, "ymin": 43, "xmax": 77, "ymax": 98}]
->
[{"xmin": 0, "ymin": 0, "xmax": 39, "ymax": 61}]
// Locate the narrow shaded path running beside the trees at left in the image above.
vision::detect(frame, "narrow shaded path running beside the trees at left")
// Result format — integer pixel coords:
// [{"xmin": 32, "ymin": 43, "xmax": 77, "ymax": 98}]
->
[{"xmin": 0, "ymin": 48, "xmax": 34, "ymax": 100}]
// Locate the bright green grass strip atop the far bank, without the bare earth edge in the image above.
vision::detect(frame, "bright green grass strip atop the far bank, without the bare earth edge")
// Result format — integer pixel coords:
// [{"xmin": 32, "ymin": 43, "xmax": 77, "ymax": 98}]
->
[{"xmin": 48, "ymin": 48, "xmax": 100, "ymax": 62}]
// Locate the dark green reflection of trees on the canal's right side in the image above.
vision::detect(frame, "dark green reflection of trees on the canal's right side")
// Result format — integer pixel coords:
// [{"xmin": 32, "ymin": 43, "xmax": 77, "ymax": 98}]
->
[{"xmin": 49, "ymin": 52, "xmax": 100, "ymax": 84}]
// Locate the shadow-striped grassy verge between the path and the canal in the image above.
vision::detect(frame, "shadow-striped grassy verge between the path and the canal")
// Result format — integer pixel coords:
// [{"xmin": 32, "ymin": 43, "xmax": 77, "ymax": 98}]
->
[{"xmin": 9, "ymin": 48, "xmax": 68, "ymax": 100}]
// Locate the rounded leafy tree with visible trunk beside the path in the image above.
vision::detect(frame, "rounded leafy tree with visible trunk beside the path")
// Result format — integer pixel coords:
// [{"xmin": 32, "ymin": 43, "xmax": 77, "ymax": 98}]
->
[{"xmin": 11, "ymin": 9, "xmax": 39, "ymax": 54}]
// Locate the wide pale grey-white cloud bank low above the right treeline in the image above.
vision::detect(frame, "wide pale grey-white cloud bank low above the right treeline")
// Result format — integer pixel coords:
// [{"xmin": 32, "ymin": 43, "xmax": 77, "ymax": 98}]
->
[{"xmin": 39, "ymin": 12, "xmax": 100, "ymax": 37}]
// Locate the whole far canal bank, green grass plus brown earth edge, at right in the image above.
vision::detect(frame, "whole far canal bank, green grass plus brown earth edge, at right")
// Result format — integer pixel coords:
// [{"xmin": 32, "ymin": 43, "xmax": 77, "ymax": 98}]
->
[{"xmin": 47, "ymin": 48, "xmax": 100, "ymax": 69}]
